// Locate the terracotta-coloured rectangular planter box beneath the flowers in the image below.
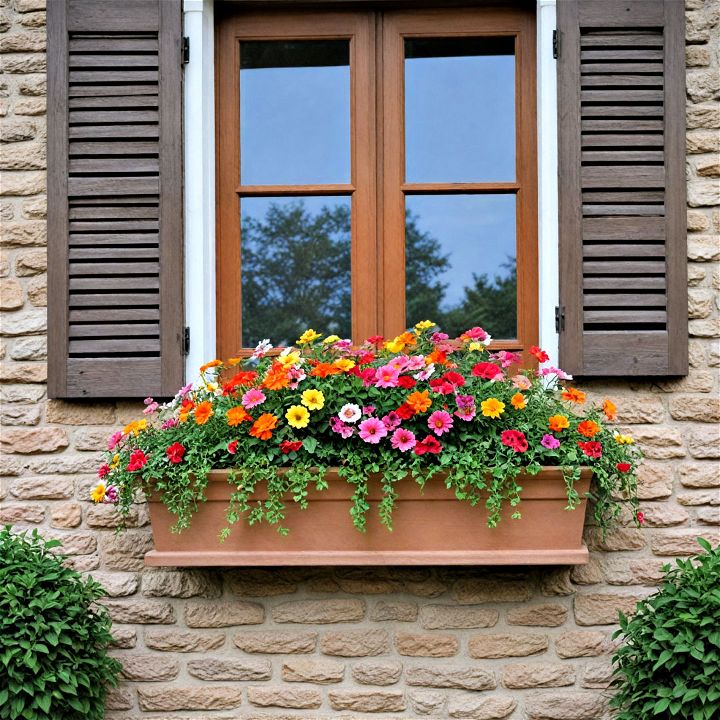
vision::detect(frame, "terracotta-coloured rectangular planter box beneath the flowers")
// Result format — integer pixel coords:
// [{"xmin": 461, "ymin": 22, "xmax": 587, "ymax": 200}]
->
[{"xmin": 145, "ymin": 468, "xmax": 591, "ymax": 567}]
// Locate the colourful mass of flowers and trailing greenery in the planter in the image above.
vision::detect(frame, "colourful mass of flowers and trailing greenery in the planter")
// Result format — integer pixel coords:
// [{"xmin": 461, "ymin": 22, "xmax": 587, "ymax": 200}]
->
[{"xmin": 92, "ymin": 321, "xmax": 641, "ymax": 537}]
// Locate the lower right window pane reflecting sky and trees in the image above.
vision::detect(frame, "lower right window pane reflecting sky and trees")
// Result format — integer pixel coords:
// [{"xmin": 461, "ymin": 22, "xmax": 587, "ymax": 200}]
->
[{"xmin": 405, "ymin": 195, "xmax": 517, "ymax": 340}]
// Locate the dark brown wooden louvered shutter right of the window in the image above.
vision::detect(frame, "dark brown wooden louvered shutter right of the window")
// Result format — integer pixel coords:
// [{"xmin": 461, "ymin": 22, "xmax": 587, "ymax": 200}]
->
[{"xmin": 558, "ymin": 0, "xmax": 688, "ymax": 376}]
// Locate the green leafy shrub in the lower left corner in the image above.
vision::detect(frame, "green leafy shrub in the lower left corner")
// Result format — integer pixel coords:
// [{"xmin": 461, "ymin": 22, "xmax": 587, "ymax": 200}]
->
[{"xmin": 0, "ymin": 526, "xmax": 120, "ymax": 720}]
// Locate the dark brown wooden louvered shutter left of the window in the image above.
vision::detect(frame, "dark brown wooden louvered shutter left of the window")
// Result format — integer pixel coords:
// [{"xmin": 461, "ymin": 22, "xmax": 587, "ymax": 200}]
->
[{"xmin": 48, "ymin": 0, "xmax": 184, "ymax": 398}]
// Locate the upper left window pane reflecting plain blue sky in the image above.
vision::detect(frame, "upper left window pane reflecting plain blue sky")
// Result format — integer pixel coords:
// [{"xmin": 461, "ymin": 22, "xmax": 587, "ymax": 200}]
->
[{"xmin": 240, "ymin": 40, "xmax": 350, "ymax": 185}]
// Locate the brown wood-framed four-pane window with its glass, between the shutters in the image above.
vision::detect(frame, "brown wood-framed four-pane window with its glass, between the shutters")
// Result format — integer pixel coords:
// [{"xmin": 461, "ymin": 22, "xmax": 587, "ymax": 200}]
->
[{"xmin": 216, "ymin": 7, "xmax": 538, "ymax": 356}]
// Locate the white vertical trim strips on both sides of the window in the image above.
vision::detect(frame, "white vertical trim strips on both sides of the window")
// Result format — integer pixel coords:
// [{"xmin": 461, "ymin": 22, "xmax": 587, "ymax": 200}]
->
[{"xmin": 183, "ymin": 0, "xmax": 559, "ymax": 380}]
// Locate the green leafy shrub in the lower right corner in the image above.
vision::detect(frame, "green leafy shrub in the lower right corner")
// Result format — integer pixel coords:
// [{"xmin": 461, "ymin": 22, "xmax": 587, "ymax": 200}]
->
[{"xmin": 611, "ymin": 538, "xmax": 720, "ymax": 720}]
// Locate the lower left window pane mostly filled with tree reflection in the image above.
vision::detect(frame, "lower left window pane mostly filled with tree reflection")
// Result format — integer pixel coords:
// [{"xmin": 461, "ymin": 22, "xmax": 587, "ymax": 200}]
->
[{"xmin": 240, "ymin": 197, "xmax": 350, "ymax": 347}]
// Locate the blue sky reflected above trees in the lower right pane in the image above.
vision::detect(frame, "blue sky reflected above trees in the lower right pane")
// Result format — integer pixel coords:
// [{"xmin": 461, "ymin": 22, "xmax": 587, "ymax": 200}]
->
[{"xmin": 405, "ymin": 195, "xmax": 515, "ymax": 310}]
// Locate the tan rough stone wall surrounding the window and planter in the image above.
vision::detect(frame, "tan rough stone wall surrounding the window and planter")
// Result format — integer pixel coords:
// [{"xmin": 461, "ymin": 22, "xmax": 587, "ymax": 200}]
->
[{"xmin": 0, "ymin": 0, "xmax": 720, "ymax": 720}]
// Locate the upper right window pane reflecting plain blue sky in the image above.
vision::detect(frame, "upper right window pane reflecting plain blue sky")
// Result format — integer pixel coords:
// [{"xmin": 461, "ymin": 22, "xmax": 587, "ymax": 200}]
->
[{"xmin": 405, "ymin": 38, "xmax": 515, "ymax": 182}]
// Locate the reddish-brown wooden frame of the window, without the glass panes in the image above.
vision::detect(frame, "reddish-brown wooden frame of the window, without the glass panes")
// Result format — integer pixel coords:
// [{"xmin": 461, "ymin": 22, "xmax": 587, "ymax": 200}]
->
[{"xmin": 215, "ymin": 0, "xmax": 539, "ymax": 362}]
